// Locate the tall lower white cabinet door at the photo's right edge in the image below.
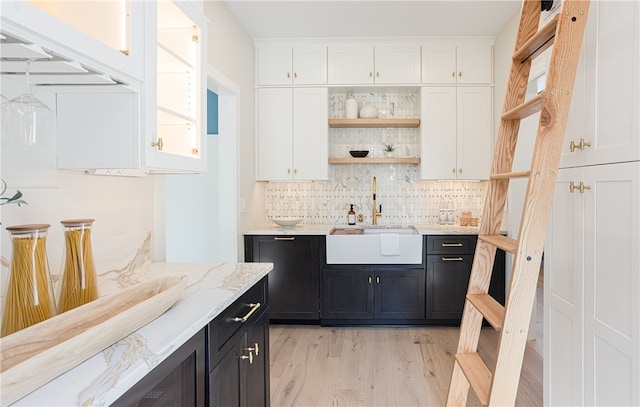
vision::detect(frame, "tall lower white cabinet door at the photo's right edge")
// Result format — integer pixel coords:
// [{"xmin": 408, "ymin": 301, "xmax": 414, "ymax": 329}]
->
[{"xmin": 581, "ymin": 161, "xmax": 640, "ymax": 406}]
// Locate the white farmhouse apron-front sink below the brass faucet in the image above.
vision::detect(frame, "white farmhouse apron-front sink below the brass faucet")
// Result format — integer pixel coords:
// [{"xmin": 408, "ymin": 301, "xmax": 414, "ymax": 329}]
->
[{"xmin": 327, "ymin": 226, "xmax": 423, "ymax": 264}]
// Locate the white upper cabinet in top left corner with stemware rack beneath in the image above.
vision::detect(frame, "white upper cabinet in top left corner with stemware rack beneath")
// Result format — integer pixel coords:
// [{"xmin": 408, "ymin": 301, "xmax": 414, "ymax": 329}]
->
[{"xmin": 0, "ymin": 1, "xmax": 144, "ymax": 86}]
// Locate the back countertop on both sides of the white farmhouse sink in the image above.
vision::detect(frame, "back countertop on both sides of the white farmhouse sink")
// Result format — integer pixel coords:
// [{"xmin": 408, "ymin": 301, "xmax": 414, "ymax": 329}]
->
[{"xmin": 244, "ymin": 223, "xmax": 480, "ymax": 235}]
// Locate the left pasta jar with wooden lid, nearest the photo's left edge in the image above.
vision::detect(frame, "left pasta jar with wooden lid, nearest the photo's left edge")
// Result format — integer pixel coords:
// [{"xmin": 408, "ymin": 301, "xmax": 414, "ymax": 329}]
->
[{"xmin": 0, "ymin": 224, "xmax": 55, "ymax": 336}]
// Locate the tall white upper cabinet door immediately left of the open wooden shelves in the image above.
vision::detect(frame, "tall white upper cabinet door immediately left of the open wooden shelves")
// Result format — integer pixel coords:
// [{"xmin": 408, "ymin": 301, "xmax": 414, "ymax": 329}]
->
[{"xmin": 293, "ymin": 88, "xmax": 329, "ymax": 180}]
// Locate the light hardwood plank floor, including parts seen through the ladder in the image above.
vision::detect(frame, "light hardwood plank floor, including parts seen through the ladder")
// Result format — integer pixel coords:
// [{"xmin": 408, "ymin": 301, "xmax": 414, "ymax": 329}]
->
[{"xmin": 270, "ymin": 287, "xmax": 542, "ymax": 407}]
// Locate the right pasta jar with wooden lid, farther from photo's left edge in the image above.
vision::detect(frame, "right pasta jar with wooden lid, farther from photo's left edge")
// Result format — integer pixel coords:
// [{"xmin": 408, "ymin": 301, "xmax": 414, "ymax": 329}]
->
[{"xmin": 58, "ymin": 219, "xmax": 98, "ymax": 313}]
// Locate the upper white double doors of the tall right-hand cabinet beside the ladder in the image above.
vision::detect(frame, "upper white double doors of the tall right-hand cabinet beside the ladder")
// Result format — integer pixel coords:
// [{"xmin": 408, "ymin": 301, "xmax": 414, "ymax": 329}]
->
[{"xmin": 561, "ymin": 1, "xmax": 640, "ymax": 167}]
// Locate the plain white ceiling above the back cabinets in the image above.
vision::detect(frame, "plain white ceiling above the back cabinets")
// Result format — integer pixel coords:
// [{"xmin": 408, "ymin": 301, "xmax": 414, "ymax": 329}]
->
[{"xmin": 225, "ymin": 0, "xmax": 522, "ymax": 39}]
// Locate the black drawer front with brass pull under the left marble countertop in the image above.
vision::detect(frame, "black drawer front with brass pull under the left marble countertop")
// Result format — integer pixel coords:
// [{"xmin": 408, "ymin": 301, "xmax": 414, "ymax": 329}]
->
[{"xmin": 209, "ymin": 279, "xmax": 268, "ymax": 365}]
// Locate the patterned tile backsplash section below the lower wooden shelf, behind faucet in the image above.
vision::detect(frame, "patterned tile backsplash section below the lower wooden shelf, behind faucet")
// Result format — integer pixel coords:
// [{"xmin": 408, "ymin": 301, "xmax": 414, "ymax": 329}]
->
[{"xmin": 265, "ymin": 175, "xmax": 488, "ymax": 225}]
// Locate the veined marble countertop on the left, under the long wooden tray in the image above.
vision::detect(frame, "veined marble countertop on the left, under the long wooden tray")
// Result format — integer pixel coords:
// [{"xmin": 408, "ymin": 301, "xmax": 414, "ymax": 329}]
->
[{"xmin": 12, "ymin": 262, "xmax": 273, "ymax": 407}]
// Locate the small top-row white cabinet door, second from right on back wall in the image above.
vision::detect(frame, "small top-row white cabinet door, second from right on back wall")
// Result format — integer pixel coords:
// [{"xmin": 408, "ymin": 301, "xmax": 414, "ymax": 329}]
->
[{"xmin": 422, "ymin": 44, "xmax": 457, "ymax": 83}]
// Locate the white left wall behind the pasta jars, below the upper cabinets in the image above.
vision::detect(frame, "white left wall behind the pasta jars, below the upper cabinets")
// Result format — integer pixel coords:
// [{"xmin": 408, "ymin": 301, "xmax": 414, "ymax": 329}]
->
[{"xmin": 0, "ymin": 77, "xmax": 154, "ymax": 281}]
